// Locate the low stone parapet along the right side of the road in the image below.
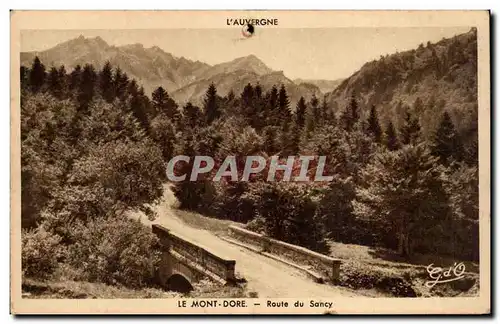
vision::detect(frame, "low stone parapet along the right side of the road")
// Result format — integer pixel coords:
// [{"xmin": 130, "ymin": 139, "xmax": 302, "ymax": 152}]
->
[{"xmin": 229, "ymin": 225, "xmax": 342, "ymax": 283}]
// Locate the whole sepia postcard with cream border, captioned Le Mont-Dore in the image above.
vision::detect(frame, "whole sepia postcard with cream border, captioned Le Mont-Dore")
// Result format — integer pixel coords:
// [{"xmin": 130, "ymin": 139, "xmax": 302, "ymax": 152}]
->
[{"xmin": 11, "ymin": 11, "xmax": 490, "ymax": 314}]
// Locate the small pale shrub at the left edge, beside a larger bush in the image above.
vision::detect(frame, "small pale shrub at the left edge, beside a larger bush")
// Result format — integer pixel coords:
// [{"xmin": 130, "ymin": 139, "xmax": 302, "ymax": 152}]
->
[{"xmin": 21, "ymin": 226, "xmax": 62, "ymax": 279}]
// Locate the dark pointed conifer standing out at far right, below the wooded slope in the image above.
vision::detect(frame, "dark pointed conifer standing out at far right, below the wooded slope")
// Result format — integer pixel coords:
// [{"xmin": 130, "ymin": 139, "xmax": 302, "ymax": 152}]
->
[{"xmin": 432, "ymin": 111, "xmax": 462, "ymax": 164}]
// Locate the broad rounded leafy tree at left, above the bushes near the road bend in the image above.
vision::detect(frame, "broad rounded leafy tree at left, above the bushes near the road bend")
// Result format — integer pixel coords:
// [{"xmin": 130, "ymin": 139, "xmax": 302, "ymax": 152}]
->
[{"xmin": 50, "ymin": 140, "xmax": 165, "ymax": 224}]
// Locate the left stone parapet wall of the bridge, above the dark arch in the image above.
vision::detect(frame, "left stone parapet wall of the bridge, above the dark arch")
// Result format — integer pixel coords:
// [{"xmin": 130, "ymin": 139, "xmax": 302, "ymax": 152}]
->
[{"xmin": 152, "ymin": 224, "xmax": 236, "ymax": 283}]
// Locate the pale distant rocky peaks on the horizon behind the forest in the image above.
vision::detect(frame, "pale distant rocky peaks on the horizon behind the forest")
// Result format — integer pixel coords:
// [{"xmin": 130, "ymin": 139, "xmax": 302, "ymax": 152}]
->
[{"xmin": 21, "ymin": 36, "xmax": 332, "ymax": 105}]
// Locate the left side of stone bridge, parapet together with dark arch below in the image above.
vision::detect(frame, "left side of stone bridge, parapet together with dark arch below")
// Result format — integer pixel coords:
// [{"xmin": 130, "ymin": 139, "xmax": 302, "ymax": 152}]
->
[{"xmin": 152, "ymin": 224, "xmax": 236, "ymax": 292}]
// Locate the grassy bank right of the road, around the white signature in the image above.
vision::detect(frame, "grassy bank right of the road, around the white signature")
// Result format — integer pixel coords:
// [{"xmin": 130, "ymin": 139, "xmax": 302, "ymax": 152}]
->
[{"xmin": 330, "ymin": 242, "xmax": 479, "ymax": 297}]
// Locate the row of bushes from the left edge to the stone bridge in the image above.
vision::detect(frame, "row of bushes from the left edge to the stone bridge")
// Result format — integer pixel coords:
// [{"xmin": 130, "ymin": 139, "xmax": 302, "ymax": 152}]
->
[{"xmin": 22, "ymin": 217, "xmax": 160, "ymax": 288}]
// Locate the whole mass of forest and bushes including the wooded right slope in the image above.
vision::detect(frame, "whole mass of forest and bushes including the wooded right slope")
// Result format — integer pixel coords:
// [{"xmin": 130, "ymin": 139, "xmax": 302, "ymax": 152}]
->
[{"xmin": 20, "ymin": 27, "xmax": 479, "ymax": 294}]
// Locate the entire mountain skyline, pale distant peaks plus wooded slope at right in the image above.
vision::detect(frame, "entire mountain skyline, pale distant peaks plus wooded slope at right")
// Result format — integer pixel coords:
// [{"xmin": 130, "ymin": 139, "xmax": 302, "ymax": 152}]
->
[{"xmin": 21, "ymin": 28, "xmax": 478, "ymax": 134}]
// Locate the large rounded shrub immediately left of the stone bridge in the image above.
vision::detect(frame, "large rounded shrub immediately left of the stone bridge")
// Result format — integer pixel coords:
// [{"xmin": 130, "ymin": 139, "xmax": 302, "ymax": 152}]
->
[{"xmin": 67, "ymin": 217, "xmax": 160, "ymax": 288}]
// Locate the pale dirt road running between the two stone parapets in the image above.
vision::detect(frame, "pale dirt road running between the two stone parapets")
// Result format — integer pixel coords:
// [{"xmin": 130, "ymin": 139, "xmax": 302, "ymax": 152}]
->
[{"xmin": 135, "ymin": 188, "xmax": 356, "ymax": 298}]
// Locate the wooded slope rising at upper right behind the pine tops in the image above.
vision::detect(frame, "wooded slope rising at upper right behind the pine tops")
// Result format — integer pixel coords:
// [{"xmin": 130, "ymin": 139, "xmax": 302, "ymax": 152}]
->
[{"xmin": 327, "ymin": 29, "xmax": 477, "ymax": 136}]
